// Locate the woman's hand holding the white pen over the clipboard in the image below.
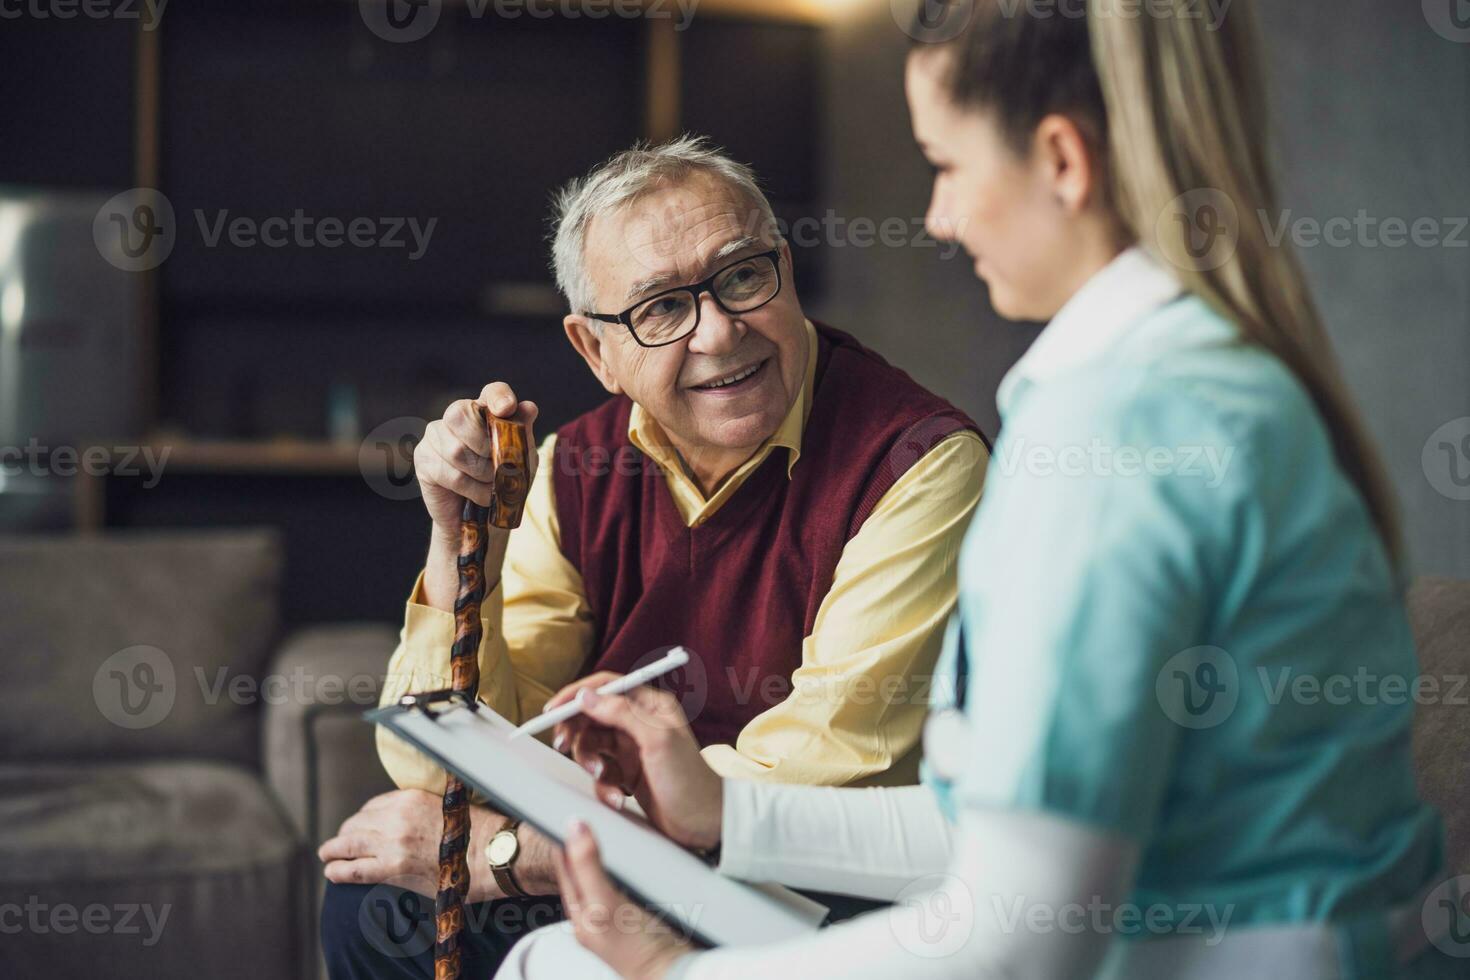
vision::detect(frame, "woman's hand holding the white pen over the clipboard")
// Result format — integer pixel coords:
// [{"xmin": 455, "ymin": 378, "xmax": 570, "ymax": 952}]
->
[{"xmin": 548, "ymin": 674, "xmax": 725, "ymax": 851}]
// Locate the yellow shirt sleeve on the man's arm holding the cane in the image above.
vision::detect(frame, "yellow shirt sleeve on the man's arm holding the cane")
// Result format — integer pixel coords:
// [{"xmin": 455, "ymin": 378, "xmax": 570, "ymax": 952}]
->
[{"xmin": 378, "ymin": 433, "xmax": 592, "ymax": 792}]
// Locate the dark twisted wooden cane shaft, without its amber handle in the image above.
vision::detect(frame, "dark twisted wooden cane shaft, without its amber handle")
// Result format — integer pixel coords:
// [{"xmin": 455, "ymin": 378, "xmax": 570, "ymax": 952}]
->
[{"xmin": 434, "ymin": 501, "xmax": 490, "ymax": 980}]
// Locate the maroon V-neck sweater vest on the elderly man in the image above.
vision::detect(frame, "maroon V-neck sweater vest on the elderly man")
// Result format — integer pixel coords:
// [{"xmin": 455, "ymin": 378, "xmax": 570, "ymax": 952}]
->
[{"xmin": 553, "ymin": 326, "xmax": 979, "ymax": 745}]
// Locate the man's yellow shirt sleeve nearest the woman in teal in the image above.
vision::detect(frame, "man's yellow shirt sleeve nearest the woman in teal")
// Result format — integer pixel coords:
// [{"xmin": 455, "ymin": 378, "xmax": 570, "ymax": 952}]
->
[{"xmin": 704, "ymin": 430, "xmax": 989, "ymax": 786}]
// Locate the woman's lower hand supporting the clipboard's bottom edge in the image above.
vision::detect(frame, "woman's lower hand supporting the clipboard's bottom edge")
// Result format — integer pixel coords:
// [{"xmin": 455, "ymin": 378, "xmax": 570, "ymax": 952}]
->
[{"xmin": 557, "ymin": 820, "xmax": 692, "ymax": 980}]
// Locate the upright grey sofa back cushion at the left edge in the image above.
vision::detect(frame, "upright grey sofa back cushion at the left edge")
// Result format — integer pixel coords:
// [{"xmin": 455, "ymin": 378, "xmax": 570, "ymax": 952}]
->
[{"xmin": 0, "ymin": 530, "xmax": 281, "ymax": 765}]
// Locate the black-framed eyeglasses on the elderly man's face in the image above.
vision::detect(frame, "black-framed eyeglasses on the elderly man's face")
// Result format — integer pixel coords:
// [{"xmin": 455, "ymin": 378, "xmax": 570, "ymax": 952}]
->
[{"xmin": 582, "ymin": 248, "xmax": 781, "ymax": 347}]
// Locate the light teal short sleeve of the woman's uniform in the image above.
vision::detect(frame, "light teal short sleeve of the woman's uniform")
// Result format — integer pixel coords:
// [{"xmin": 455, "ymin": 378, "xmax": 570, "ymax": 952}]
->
[{"xmin": 953, "ymin": 382, "xmax": 1223, "ymax": 840}]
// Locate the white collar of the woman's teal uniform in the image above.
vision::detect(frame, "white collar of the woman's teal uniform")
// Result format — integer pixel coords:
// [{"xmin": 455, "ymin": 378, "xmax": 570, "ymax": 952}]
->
[{"xmin": 995, "ymin": 245, "xmax": 1183, "ymax": 416}]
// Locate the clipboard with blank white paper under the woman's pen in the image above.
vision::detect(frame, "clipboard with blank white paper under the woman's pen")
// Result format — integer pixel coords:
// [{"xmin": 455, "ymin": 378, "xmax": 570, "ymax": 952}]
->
[{"xmin": 363, "ymin": 691, "xmax": 828, "ymax": 946}]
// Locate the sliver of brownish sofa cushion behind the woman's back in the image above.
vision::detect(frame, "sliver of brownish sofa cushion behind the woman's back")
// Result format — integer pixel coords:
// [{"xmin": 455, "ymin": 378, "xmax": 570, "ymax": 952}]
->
[{"xmin": 1408, "ymin": 579, "xmax": 1470, "ymax": 874}]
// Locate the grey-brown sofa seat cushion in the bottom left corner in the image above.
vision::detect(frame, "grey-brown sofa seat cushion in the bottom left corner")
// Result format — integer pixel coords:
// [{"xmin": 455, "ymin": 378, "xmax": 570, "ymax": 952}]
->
[{"xmin": 0, "ymin": 763, "xmax": 305, "ymax": 980}]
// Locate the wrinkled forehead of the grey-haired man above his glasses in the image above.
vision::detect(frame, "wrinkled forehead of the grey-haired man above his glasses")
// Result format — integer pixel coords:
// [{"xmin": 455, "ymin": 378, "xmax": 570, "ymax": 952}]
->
[{"xmin": 585, "ymin": 173, "xmax": 773, "ymax": 309}]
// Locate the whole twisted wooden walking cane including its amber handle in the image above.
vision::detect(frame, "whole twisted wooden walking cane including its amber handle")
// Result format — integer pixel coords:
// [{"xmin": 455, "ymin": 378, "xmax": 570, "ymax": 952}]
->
[{"xmin": 434, "ymin": 404, "xmax": 529, "ymax": 980}]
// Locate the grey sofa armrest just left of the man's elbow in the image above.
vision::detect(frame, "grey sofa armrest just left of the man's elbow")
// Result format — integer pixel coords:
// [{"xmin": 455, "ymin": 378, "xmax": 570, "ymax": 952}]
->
[{"xmin": 262, "ymin": 624, "xmax": 398, "ymax": 851}]
